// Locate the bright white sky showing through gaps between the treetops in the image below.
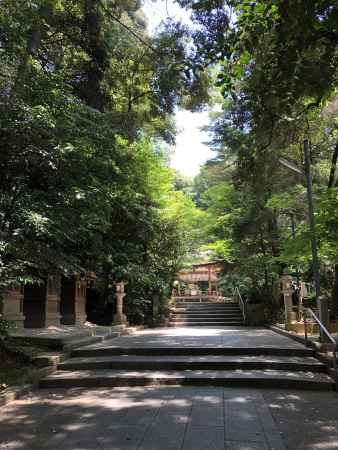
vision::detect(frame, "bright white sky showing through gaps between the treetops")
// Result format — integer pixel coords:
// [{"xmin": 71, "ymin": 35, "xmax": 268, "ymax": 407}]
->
[{"xmin": 143, "ymin": 0, "xmax": 214, "ymax": 177}]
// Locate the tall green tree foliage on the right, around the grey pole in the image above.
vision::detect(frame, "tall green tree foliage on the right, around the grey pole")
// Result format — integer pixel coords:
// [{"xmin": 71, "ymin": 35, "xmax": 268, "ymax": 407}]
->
[{"xmin": 179, "ymin": 0, "xmax": 338, "ymax": 306}]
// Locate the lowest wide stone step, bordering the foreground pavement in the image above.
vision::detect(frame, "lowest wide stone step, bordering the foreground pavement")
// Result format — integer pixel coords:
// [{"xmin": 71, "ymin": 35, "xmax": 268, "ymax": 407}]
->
[{"xmin": 40, "ymin": 370, "xmax": 335, "ymax": 390}]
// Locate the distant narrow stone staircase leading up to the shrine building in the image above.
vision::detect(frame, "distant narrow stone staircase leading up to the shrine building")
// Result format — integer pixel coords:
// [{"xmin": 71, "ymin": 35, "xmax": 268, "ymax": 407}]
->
[{"xmin": 169, "ymin": 300, "xmax": 244, "ymax": 327}]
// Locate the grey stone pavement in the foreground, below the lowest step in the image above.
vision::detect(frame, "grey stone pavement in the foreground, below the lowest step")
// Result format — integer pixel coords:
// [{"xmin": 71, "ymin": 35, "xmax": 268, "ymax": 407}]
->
[{"xmin": 0, "ymin": 387, "xmax": 338, "ymax": 450}]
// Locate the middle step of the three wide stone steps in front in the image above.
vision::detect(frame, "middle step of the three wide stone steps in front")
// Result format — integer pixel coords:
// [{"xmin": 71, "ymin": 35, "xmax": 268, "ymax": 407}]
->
[{"xmin": 58, "ymin": 355, "xmax": 326, "ymax": 372}]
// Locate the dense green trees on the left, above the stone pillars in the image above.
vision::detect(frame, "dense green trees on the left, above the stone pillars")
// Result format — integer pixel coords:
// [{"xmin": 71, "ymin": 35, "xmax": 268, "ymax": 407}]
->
[{"xmin": 0, "ymin": 0, "xmax": 213, "ymax": 324}]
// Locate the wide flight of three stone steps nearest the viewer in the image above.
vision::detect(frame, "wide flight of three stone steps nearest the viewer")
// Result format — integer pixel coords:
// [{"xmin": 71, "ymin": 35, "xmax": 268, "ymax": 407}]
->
[{"xmin": 40, "ymin": 327, "xmax": 334, "ymax": 390}]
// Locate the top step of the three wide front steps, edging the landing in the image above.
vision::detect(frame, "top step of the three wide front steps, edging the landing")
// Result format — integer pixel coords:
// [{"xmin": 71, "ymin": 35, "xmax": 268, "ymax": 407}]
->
[{"xmin": 71, "ymin": 344, "xmax": 314, "ymax": 357}]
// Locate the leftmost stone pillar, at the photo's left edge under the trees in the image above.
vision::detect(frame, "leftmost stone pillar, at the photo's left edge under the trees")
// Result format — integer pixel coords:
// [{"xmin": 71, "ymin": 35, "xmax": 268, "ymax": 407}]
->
[{"xmin": 0, "ymin": 286, "xmax": 25, "ymax": 329}]
